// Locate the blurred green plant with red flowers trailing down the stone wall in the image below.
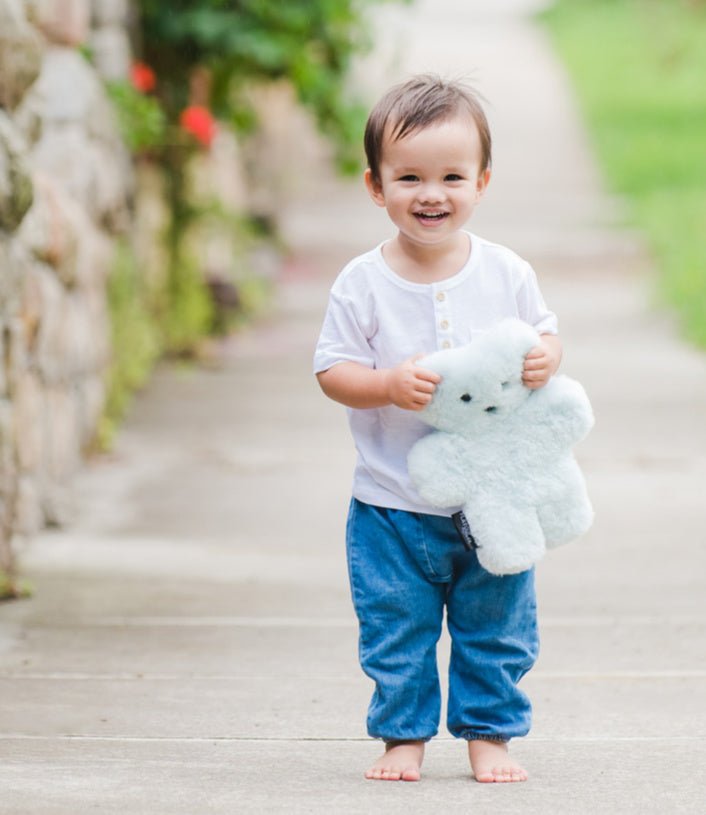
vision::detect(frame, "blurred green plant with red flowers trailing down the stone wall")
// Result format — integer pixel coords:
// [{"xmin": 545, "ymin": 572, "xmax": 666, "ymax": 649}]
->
[{"xmin": 100, "ymin": 0, "xmax": 396, "ymax": 445}]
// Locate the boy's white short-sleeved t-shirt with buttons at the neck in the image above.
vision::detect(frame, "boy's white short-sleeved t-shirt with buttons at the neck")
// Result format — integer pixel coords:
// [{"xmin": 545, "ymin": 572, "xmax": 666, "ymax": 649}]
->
[{"xmin": 314, "ymin": 235, "xmax": 557, "ymax": 515}]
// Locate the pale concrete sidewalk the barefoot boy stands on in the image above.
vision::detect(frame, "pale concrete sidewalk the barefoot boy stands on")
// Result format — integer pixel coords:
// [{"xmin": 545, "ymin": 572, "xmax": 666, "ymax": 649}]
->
[{"xmin": 0, "ymin": 0, "xmax": 706, "ymax": 815}]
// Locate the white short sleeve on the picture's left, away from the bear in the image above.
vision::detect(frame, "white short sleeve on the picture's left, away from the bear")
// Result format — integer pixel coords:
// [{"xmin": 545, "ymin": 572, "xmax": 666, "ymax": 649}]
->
[{"xmin": 314, "ymin": 292, "xmax": 375, "ymax": 374}]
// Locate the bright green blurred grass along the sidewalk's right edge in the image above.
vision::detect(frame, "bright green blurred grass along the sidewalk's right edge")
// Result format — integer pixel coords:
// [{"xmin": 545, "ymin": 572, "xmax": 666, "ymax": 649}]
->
[{"xmin": 544, "ymin": 0, "xmax": 706, "ymax": 347}]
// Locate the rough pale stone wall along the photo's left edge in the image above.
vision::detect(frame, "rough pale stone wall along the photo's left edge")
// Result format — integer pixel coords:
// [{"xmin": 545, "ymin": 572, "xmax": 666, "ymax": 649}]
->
[{"xmin": 0, "ymin": 0, "xmax": 133, "ymax": 571}]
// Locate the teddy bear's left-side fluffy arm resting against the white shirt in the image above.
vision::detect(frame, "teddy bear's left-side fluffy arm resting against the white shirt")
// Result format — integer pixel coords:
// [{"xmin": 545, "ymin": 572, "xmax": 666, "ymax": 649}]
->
[{"xmin": 408, "ymin": 432, "xmax": 469, "ymax": 508}]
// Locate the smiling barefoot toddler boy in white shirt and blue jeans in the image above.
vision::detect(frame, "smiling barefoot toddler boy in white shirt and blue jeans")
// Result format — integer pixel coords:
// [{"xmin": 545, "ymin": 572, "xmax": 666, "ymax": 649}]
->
[{"xmin": 314, "ymin": 75, "xmax": 561, "ymax": 782}]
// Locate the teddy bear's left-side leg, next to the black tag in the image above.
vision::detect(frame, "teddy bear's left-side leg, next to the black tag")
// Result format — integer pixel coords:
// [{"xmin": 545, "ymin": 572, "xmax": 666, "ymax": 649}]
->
[{"xmin": 464, "ymin": 501, "xmax": 544, "ymax": 574}]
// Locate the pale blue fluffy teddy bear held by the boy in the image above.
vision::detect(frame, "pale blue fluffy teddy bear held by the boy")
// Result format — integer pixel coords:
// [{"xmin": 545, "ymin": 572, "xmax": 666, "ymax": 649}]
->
[{"xmin": 408, "ymin": 319, "xmax": 594, "ymax": 575}]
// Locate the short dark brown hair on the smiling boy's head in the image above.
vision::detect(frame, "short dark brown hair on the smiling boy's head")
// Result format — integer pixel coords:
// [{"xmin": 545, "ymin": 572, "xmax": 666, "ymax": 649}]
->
[{"xmin": 364, "ymin": 74, "xmax": 491, "ymax": 181}]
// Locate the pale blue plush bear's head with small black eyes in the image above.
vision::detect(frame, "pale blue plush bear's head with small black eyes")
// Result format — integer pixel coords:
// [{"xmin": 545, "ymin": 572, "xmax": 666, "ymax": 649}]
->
[{"xmin": 418, "ymin": 320, "xmax": 539, "ymax": 435}]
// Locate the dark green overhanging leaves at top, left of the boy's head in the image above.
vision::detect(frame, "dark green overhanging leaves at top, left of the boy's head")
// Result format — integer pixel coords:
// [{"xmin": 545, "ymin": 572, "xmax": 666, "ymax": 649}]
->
[{"xmin": 138, "ymin": 0, "xmax": 390, "ymax": 169}]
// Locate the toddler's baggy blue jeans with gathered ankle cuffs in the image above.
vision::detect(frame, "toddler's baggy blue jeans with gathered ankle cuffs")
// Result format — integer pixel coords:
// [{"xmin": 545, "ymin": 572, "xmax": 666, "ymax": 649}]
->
[{"xmin": 346, "ymin": 498, "xmax": 539, "ymax": 741}]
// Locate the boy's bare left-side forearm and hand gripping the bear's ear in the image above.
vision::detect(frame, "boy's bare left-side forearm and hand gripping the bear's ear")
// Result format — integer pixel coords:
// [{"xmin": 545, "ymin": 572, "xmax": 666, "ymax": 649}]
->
[{"xmin": 317, "ymin": 357, "xmax": 441, "ymax": 410}]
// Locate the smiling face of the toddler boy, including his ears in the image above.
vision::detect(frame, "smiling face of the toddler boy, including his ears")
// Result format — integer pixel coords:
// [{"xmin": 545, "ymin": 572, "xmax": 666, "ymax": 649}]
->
[{"xmin": 365, "ymin": 115, "xmax": 490, "ymax": 246}]
